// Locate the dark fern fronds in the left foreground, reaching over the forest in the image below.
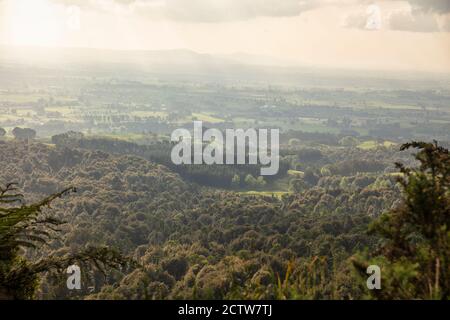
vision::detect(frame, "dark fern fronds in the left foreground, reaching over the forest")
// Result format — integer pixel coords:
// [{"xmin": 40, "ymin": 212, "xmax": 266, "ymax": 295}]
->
[{"xmin": 0, "ymin": 184, "xmax": 129, "ymax": 299}]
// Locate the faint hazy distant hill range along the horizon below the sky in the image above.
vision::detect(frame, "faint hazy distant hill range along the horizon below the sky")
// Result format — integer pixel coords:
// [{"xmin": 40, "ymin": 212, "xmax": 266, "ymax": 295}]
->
[{"xmin": 0, "ymin": 46, "xmax": 450, "ymax": 88}]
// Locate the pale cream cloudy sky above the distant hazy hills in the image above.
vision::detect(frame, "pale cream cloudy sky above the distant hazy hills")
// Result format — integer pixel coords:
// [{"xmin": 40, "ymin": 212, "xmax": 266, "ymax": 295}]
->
[{"xmin": 0, "ymin": 0, "xmax": 450, "ymax": 73}]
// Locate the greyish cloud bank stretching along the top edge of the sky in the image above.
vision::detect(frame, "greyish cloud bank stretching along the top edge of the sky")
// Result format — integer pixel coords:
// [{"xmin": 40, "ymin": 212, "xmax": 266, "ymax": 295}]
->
[{"xmin": 46, "ymin": 0, "xmax": 450, "ymax": 32}]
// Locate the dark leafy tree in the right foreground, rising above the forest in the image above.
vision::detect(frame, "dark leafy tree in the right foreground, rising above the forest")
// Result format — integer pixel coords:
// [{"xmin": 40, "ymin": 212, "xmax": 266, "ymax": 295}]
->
[{"xmin": 354, "ymin": 142, "xmax": 450, "ymax": 299}]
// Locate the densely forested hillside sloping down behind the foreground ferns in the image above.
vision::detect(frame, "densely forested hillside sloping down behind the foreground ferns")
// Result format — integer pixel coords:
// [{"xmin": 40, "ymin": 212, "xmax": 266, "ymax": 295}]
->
[{"xmin": 0, "ymin": 142, "xmax": 395, "ymax": 299}]
